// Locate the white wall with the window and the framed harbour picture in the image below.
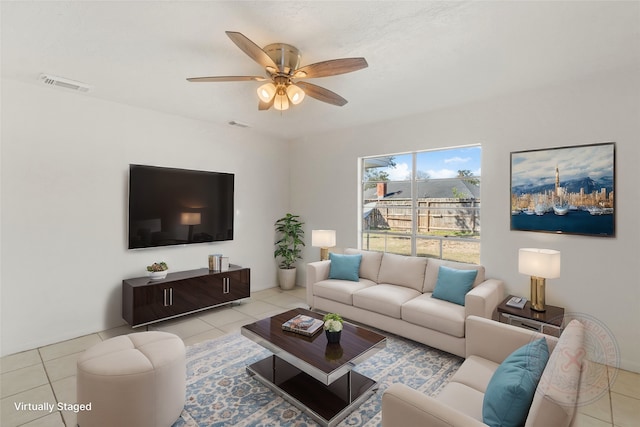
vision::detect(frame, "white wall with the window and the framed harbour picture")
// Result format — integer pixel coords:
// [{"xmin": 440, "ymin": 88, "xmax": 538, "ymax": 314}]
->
[{"xmin": 291, "ymin": 65, "xmax": 640, "ymax": 371}]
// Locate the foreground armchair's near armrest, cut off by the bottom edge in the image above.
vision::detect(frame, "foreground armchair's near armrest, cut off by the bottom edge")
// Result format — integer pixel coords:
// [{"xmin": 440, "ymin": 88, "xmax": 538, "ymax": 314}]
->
[{"xmin": 382, "ymin": 383, "xmax": 486, "ymax": 427}]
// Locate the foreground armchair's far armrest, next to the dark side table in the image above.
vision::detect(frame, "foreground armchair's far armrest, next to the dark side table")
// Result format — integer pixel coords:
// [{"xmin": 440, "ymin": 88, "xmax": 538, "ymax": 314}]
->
[{"xmin": 465, "ymin": 316, "xmax": 558, "ymax": 364}]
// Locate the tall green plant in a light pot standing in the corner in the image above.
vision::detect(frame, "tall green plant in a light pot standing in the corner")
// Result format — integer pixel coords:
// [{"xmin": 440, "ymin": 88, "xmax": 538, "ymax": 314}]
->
[{"xmin": 273, "ymin": 213, "xmax": 304, "ymax": 289}]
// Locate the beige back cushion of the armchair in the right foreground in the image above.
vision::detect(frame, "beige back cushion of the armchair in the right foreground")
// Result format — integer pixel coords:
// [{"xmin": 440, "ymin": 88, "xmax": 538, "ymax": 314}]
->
[{"xmin": 525, "ymin": 320, "xmax": 586, "ymax": 427}]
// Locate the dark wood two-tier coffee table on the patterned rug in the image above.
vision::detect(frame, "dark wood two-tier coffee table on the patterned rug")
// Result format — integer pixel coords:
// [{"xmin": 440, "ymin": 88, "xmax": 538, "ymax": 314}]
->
[{"xmin": 241, "ymin": 308, "xmax": 387, "ymax": 427}]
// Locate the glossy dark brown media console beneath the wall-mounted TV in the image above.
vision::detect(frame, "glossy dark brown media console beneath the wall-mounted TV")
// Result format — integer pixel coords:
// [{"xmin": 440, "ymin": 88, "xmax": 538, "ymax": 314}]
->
[{"xmin": 122, "ymin": 265, "xmax": 251, "ymax": 327}]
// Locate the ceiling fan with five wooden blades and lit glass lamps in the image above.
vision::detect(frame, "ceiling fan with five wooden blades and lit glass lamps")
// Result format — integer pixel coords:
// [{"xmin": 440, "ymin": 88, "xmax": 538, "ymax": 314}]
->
[{"xmin": 187, "ymin": 31, "xmax": 368, "ymax": 110}]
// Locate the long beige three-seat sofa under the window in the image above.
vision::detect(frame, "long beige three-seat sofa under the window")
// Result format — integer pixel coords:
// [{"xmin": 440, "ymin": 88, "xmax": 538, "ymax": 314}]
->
[{"xmin": 306, "ymin": 249, "xmax": 504, "ymax": 357}]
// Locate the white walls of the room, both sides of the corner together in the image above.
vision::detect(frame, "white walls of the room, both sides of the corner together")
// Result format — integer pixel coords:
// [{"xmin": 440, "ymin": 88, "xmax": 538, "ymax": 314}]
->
[{"xmin": 0, "ymin": 69, "xmax": 640, "ymax": 371}]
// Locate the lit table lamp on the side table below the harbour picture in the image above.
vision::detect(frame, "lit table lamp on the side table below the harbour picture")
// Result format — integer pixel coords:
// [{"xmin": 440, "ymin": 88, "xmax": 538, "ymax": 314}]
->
[{"xmin": 518, "ymin": 248, "xmax": 560, "ymax": 311}]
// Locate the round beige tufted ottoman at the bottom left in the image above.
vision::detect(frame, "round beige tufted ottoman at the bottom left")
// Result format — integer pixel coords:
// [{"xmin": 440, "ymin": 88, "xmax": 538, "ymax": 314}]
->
[{"xmin": 77, "ymin": 332, "xmax": 186, "ymax": 427}]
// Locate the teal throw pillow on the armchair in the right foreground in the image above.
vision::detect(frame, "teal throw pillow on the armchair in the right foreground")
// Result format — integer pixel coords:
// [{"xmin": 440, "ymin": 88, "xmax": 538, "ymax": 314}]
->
[{"xmin": 482, "ymin": 338, "xmax": 549, "ymax": 427}]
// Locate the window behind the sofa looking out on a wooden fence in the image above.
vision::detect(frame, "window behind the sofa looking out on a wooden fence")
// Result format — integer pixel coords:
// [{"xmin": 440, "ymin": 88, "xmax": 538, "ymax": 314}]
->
[{"xmin": 359, "ymin": 146, "xmax": 481, "ymax": 264}]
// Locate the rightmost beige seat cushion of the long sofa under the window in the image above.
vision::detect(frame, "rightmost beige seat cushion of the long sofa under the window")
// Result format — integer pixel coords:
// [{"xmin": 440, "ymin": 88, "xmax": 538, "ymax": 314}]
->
[{"xmin": 402, "ymin": 293, "xmax": 465, "ymax": 338}]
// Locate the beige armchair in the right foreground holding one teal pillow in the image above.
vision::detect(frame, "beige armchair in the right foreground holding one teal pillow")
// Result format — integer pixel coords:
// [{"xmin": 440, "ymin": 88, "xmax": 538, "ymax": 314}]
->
[{"xmin": 382, "ymin": 316, "xmax": 588, "ymax": 427}]
